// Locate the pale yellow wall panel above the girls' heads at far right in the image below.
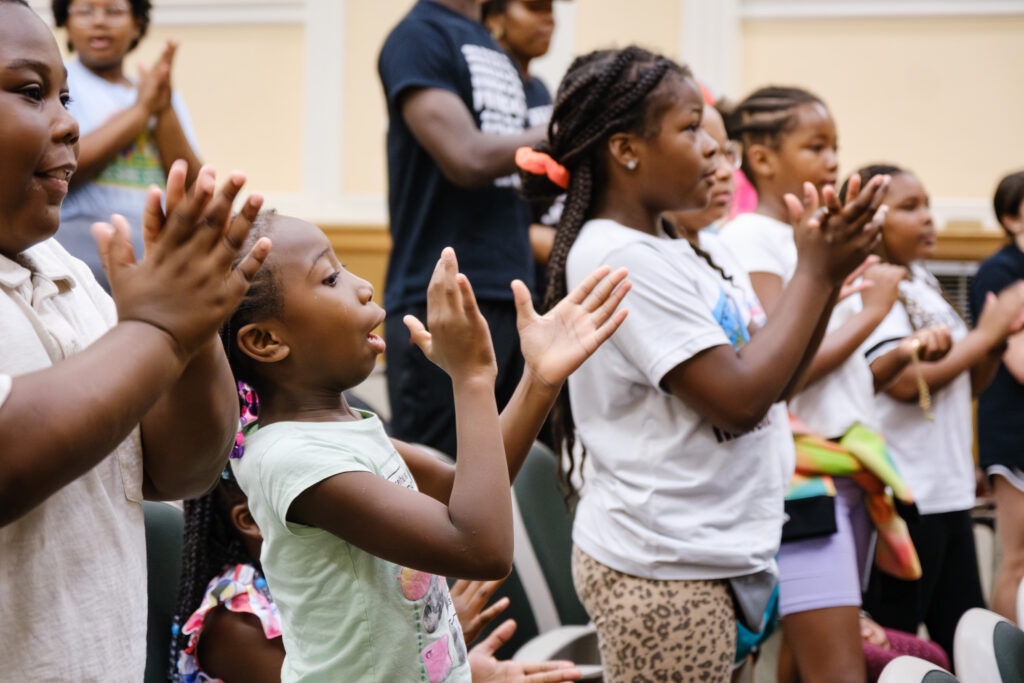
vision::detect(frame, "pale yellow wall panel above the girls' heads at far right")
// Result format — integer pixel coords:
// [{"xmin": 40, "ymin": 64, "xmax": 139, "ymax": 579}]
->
[{"xmin": 737, "ymin": 16, "xmax": 1024, "ymax": 200}]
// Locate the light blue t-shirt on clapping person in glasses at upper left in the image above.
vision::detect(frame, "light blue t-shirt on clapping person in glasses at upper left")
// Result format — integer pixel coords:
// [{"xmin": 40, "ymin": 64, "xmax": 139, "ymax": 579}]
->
[{"xmin": 57, "ymin": 59, "xmax": 199, "ymax": 282}]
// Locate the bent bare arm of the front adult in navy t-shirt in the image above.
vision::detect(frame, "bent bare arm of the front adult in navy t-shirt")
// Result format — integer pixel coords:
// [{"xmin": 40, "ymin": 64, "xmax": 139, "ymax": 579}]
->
[{"xmin": 401, "ymin": 88, "xmax": 547, "ymax": 188}]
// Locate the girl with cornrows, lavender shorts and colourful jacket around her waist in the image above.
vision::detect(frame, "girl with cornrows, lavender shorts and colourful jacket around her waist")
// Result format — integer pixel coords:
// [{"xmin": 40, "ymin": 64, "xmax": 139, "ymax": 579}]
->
[{"xmin": 721, "ymin": 86, "xmax": 948, "ymax": 683}]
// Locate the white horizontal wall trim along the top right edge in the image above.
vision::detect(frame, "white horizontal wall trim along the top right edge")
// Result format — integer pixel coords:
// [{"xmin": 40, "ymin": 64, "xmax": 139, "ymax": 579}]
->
[{"xmin": 745, "ymin": 0, "xmax": 1024, "ymax": 19}]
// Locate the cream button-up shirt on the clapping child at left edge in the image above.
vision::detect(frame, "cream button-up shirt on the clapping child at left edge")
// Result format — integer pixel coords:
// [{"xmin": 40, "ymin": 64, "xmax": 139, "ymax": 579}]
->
[{"xmin": 0, "ymin": 240, "xmax": 146, "ymax": 681}]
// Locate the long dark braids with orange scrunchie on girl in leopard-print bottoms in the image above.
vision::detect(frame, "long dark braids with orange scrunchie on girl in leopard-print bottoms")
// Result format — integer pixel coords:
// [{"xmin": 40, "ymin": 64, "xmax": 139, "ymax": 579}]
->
[{"xmin": 522, "ymin": 46, "xmax": 690, "ymax": 501}]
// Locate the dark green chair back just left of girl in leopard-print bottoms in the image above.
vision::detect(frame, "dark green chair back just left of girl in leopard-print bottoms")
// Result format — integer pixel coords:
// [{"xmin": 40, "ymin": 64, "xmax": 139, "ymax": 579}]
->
[{"xmin": 512, "ymin": 441, "xmax": 590, "ymax": 631}]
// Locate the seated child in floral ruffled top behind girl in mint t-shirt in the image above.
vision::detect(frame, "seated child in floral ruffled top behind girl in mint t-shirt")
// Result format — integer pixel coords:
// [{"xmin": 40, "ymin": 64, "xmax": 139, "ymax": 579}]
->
[{"xmin": 171, "ymin": 467, "xmax": 581, "ymax": 683}]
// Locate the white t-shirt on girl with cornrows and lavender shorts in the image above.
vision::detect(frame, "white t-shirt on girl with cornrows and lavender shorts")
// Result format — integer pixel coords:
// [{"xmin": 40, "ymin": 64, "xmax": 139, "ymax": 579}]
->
[{"xmin": 721, "ymin": 213, "xmax": 879, "ymax": 438}]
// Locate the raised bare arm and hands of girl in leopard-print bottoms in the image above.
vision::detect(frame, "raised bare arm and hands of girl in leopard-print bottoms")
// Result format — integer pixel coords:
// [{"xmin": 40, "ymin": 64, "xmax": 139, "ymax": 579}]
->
[{"xmin": 662, "ymin": 178, "xmax": 884, "ymax": 433}]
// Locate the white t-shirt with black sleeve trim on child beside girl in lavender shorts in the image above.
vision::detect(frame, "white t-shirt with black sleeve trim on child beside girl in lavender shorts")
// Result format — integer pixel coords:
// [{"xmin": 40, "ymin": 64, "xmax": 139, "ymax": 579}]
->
[{"xmin": 862, "ymin": 264, "xmax": 975, "ymax": 514}]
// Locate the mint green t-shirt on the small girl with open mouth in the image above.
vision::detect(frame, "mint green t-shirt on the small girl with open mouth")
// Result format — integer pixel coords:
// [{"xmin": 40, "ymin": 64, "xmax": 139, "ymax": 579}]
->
[{"xmin": 231, "ymin": 413, "xmax": 470, "ymax": 683}]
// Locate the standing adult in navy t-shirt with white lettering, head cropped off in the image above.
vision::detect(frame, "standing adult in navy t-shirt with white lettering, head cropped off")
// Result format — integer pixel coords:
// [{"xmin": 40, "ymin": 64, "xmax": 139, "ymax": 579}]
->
[{"xmin": 378, "ymin": 0, "xmax": 545, "ymax": 456}]
